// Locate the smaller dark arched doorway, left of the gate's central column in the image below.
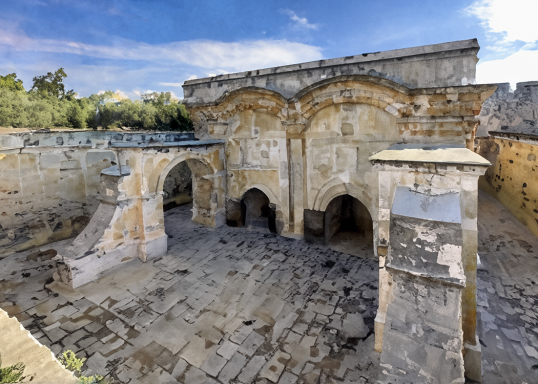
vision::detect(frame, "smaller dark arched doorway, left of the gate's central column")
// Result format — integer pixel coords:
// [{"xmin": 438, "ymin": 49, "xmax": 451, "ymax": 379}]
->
[{"xmin": 241, "ymin": 188, "xmax": 276, "ymax": 233}]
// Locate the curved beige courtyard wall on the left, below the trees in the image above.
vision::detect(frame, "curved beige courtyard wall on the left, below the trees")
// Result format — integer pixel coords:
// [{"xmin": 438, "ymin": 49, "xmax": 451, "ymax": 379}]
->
[{"xmin": 0, "ymin": 148, "xmax": 116, "ymax": 254}]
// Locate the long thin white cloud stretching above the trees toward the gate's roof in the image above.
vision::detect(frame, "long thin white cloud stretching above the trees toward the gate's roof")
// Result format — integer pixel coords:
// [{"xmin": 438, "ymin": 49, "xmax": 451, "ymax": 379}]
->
[{"xmin": 0, "ymin": 28, "xmax": 322, "ymax": 73}]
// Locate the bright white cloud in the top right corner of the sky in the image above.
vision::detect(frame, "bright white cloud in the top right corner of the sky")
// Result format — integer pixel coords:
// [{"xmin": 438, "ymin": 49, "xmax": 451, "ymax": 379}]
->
[{"xmin": 465, "ymin": 0, "xmax": 538, "ymax": 50}]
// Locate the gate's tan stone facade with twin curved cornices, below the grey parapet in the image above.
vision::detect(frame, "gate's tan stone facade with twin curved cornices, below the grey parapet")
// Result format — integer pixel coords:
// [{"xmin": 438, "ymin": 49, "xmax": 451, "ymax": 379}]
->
[{"xmin": 190, "ymin": 76, "xmax": 495, "ymax": 249}]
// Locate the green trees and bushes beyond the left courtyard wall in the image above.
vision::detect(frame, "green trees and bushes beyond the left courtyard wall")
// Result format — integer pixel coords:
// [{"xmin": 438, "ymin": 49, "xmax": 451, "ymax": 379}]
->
[{"xmin": 0, "ymin": 68, "xmax": 192, "ymax": 131}]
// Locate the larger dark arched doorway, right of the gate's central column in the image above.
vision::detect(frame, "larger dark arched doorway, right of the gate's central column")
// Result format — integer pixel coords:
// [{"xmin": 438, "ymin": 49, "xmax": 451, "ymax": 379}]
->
[{"xmin": 323, "ymin": 195, "xmax": 373, "ymax": 257}]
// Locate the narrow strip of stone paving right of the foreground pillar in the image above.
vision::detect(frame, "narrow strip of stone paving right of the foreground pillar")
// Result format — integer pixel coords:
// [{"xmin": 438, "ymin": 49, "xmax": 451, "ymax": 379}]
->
[{"xmin": 477, "ymin": 192, "xmax": 538, "ymax": 384}]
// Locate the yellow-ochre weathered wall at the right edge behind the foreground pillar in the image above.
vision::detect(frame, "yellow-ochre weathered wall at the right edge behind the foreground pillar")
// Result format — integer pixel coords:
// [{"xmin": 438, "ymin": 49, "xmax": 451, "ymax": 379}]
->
[{"xmin": 476, "ymin": 134, "xmax": 538, "ymax": 237}]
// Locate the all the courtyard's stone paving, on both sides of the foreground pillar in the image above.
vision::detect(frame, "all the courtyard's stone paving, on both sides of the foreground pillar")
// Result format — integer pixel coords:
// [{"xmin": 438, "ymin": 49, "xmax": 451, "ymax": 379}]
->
[{"xmin": 0, "ymin": 193, "xmax": 538, "ymax": 384}]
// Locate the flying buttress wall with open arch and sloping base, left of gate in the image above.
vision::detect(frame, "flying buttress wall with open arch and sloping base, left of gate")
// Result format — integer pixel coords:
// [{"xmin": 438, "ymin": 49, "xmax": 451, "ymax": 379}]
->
[{"xmin": 55, "ymin": 141, "xmax": 226, "ymax": 288}]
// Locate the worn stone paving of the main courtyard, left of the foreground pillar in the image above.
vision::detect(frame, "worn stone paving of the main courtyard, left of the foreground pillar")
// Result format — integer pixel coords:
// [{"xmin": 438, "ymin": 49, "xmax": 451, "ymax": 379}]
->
[{"xmin": 0, "ymin": 202, "xmax": 379, "ymax": 384}]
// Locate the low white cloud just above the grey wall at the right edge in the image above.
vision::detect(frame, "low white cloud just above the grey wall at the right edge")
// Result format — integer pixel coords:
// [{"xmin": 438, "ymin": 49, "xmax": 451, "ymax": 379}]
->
[{"xmin": 476, "ymin": 50, "xmax": 538, "ymax": 89}]
